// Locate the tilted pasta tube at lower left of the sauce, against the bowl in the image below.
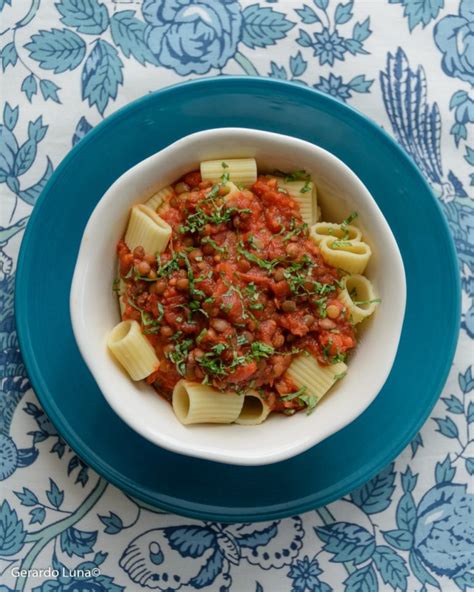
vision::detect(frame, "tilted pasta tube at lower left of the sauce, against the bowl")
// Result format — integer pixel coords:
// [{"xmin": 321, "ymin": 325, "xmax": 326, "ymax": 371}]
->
[{"xmin": 107, "ymin": 321, "xmax": 160, "ymax": 380}]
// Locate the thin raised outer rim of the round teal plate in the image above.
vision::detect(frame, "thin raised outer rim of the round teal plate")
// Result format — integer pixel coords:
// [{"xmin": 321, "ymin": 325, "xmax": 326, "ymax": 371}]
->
[{"xmin": 14, "ymin": 76, "xmax": 461, "ymax": 522}]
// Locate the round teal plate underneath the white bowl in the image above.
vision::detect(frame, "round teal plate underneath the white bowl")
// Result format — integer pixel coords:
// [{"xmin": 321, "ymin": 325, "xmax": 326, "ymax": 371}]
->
[{"xmin": 16, "ymin": 77, "xmax": 460, "ymax": 522}]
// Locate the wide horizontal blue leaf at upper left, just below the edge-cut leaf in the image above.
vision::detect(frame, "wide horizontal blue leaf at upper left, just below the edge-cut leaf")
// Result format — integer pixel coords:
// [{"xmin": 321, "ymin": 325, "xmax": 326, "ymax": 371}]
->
[{"xmin": 25, "ymin": 29, "xmax": 86, "ymax": 74}]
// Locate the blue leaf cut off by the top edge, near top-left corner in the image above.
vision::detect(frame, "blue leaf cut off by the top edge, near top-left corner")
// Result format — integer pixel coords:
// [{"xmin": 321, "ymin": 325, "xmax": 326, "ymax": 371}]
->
[{"xmin": 56, "ymin": 0, "xmax": 109, "ymax": 35}]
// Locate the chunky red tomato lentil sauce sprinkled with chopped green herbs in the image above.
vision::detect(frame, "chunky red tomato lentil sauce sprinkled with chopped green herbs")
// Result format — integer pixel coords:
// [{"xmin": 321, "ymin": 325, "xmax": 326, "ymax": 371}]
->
[{"xmin": 117, "ymin": 172, "xmax": 356, "ymax": 412}]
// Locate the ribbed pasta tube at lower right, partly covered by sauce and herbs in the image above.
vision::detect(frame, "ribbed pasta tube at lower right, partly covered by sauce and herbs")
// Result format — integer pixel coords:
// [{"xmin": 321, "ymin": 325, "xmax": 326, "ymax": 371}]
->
[{"xmin": 286, "ymin": 355, "xmax": 347, "ymax": 401}]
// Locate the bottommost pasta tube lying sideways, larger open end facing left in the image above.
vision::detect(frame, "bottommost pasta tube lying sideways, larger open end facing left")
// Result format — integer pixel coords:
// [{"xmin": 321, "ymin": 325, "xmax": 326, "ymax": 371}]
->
[{"xmin": 172, "ymin": 380, "xmax": 244, "ymax": 425}]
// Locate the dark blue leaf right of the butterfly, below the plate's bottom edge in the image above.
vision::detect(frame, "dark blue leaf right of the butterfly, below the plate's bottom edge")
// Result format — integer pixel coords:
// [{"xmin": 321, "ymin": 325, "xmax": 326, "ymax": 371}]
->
[{"xmin": 315, "ymin": 522, "xmax": 375, "ymax": 565}]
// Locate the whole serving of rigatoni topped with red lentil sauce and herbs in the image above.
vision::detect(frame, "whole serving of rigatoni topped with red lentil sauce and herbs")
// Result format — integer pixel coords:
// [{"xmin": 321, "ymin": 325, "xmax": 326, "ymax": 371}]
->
[{"xmin": 108, "ymin": 158, "xmax": 378, "ymax": 429}]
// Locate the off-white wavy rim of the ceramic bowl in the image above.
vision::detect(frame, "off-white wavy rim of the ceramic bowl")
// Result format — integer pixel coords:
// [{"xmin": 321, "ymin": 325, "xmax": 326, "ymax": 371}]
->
[{"xmin": 69, "ymin": 127, "xmax": 407, "ymax": 466}]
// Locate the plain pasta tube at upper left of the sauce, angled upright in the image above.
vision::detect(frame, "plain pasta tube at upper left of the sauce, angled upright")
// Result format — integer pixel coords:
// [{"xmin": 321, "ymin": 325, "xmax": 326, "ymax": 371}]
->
[{"xmin": 125, "ymin": 204, "xmax": 171, "ymax": 255}]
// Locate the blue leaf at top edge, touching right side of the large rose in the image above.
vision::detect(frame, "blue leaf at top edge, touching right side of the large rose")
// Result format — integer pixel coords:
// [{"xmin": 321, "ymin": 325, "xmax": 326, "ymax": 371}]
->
[{"xmin": 242, "ymin": 4, "xmax": 295, "ymax": 49}]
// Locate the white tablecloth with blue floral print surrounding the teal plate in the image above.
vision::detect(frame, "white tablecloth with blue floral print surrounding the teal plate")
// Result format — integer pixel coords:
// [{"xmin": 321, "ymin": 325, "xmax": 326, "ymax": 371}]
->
[{"xmin": 0, "ymin": 0, "xmax": 474, "ymax": 592}]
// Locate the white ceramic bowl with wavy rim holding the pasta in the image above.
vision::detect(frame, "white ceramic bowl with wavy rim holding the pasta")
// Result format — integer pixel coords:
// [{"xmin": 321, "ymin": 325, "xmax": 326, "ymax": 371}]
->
[{"xmin": 70, "ymin": 128, "xmax": 406, "ymax": 465}]
